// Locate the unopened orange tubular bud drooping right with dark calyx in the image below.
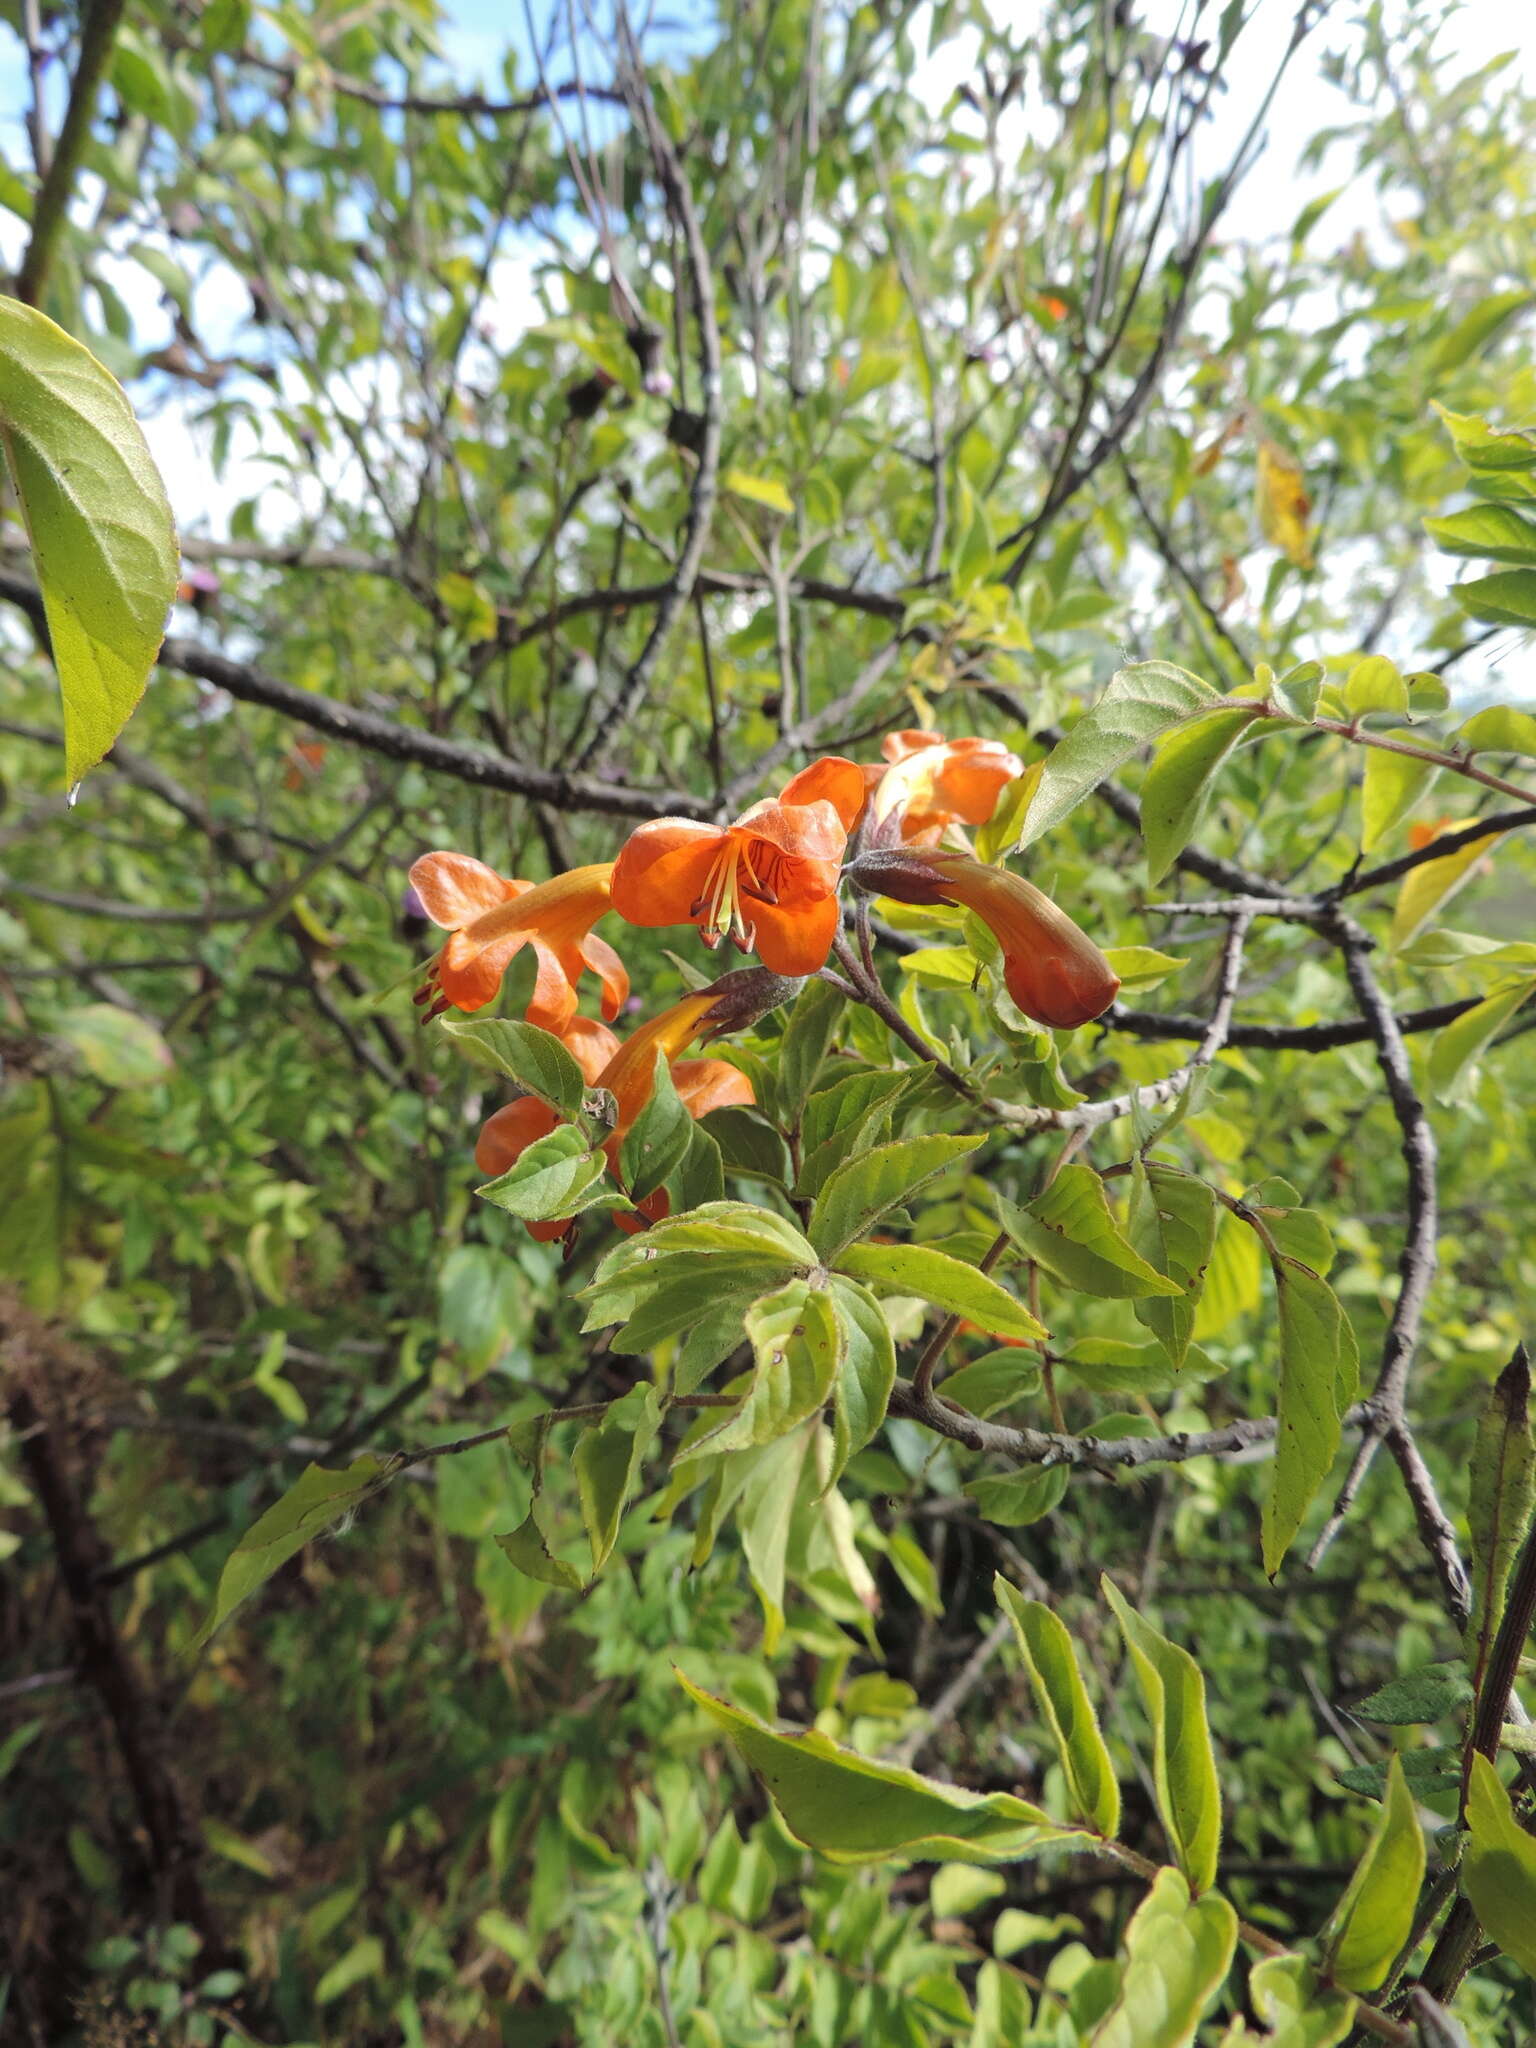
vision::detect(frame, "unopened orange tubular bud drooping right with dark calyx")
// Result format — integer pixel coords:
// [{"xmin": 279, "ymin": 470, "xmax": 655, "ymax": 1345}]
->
[{"xmin": 848, "ymin": 846, "xmax": 1120, "ymax": 1030}]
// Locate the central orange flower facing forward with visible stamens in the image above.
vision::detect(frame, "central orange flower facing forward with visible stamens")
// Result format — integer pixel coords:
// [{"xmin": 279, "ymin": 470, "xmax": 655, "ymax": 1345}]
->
[{"xmin": 612, "ymin": 756, "xmax": 864, "ymax": 975}]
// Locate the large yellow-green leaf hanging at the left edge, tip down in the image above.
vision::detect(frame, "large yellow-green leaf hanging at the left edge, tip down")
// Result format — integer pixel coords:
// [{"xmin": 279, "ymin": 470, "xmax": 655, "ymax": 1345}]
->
[{"xmin": 0, "ymin": 299, "xmax": 180, "ymax": 782}]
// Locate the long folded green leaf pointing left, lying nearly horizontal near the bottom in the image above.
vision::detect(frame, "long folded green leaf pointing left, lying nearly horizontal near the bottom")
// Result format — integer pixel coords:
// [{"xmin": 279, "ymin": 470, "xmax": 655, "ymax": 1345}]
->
[{"xmin": 678, "ymin": 1671, "xmax": 1085, "ymax": 1864}]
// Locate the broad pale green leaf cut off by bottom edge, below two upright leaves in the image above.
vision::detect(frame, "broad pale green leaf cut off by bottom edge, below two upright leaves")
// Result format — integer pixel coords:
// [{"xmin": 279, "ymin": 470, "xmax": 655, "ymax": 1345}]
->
[{"xmin": 1087, "ymin": 1870, "xmax": 1237, "ymax": 2048}]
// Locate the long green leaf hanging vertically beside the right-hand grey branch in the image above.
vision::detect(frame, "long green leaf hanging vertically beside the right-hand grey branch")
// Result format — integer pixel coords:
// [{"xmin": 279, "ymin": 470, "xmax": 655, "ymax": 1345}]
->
[{"xmin": 1262, "ymin": 1257, "xmax": 1360, "ymax": 1577}]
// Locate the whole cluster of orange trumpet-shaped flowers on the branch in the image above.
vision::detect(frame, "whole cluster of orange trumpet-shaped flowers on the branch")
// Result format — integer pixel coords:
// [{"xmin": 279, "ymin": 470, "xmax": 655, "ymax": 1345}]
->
[{"xmin": 410, "ymin": 731, "xmax": 1118, "ymax": 1237}]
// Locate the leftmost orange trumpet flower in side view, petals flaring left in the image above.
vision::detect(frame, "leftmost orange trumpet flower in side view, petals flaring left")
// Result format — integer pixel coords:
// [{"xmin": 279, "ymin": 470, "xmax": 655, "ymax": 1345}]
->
[{"xmin": 410, "ymin": 854, "xmax": 629, "ymax": 1036}]
